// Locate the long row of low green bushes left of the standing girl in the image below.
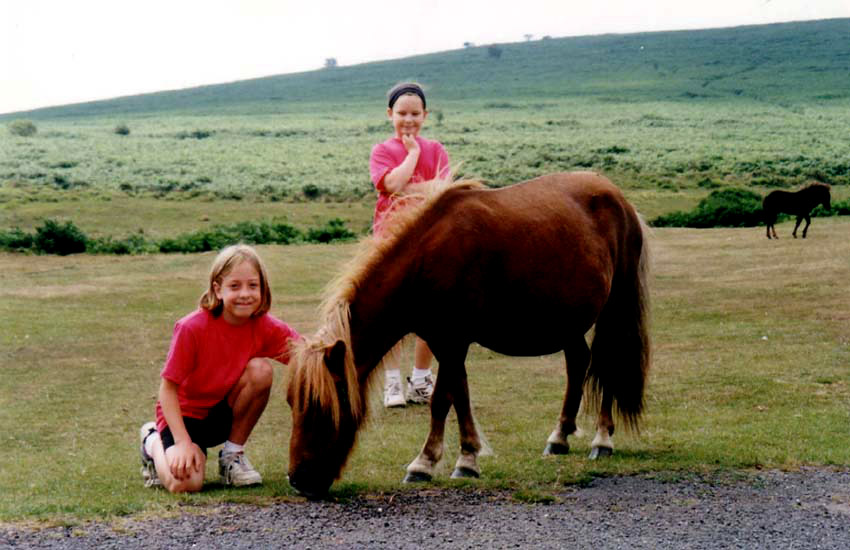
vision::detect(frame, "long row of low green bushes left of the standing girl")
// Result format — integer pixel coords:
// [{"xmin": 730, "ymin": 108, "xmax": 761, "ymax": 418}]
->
[{"xmin": 0, "ymin": 218, "xmax": 356, "ymax": 256}]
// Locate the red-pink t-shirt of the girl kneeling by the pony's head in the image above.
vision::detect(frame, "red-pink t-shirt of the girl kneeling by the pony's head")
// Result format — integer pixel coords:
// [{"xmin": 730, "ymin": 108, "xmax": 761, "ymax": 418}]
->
[{"xmin": 156, "ymin": 309, "xmax": 300, "ymax": 431}]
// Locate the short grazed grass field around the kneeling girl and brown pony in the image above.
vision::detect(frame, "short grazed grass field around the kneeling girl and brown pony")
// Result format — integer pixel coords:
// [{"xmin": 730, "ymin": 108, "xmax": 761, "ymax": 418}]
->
[{"xmin": 0, "ymin": 218, "xmax": 850, "ymax": 522}]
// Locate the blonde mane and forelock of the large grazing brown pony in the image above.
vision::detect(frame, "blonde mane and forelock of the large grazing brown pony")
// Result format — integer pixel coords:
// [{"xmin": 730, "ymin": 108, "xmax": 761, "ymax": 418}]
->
[{"xmin": 292, "ymin": 180, "xmax": 483, "ymax": 428}]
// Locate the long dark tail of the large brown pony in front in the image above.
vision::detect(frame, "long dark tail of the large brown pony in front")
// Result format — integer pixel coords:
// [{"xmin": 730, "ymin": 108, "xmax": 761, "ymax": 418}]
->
[{"xmin": 586, "ymin": 217, "xmax": 652, "ymax": 431}]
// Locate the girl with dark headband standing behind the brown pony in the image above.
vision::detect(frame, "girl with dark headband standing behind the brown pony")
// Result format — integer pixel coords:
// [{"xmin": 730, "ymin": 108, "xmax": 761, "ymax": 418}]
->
[{"xmin": 369, "ymin": 82, "xmax": 451, "ymax": 407}]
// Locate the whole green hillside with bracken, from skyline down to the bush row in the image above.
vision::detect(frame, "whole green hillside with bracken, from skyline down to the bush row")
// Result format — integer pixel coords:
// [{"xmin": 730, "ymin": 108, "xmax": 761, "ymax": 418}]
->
[{"xmin": 0, "ymin": 19, "xmax": 850, "ymax": 244}]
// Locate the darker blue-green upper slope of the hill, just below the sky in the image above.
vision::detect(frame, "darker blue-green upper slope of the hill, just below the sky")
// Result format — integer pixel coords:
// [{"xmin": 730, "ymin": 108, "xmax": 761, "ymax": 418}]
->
[{"xmin": 6, "ymin": 19, "xmax": 850, "ymax": 119}]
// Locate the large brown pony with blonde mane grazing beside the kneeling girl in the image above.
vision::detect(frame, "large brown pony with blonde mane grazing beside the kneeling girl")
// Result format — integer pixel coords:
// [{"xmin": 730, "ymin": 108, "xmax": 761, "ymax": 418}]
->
[{"xmin": 287, "ymin": 172, "xmax": 650, "ymax": 497}]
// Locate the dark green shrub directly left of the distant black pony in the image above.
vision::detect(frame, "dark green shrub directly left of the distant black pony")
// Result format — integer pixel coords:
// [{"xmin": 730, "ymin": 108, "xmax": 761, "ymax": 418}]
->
[{"xmin": 650, "ymin": 188, "xmax": 763, "ymax": 228}]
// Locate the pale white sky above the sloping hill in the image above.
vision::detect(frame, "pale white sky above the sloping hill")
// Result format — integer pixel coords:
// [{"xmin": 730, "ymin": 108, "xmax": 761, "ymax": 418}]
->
[{"xmin": 0, "ymin": 0, "xmax": 850, "ymax": 114}]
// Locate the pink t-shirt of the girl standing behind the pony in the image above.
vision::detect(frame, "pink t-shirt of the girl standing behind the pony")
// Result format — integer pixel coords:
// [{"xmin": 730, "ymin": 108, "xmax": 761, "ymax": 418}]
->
[{"xmin": 369, "ymin": 136, "xmax": 450, "ymax": 235}]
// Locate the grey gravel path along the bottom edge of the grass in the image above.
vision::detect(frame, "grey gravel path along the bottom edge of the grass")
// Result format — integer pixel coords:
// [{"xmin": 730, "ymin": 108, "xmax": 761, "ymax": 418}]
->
[{"xmin": 6, "ymin": 469, "xmax": 850, "ymax": 550}]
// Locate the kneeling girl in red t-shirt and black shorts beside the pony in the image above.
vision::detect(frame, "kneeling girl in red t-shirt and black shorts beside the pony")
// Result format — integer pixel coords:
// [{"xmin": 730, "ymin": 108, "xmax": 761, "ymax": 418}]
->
[{"xmin": 141, "ymin": 244, "xmax": 299, "ymax": 493}]
